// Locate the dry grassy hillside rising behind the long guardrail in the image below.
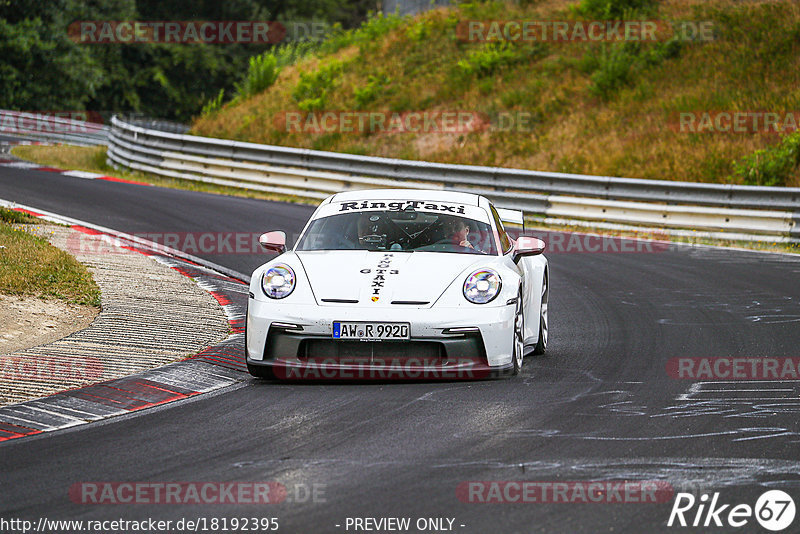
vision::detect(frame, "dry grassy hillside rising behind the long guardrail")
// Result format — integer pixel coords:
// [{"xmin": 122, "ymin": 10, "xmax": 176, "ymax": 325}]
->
[{"xmin": 193, "ymin": 0, "xmax": 800, "ymax": 186}]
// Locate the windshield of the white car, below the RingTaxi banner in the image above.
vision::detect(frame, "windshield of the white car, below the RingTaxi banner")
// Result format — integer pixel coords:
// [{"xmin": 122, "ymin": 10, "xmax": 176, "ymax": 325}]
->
[{"xmin": 297, "ymin": 209, "xmax": 497, "ymax": 255}]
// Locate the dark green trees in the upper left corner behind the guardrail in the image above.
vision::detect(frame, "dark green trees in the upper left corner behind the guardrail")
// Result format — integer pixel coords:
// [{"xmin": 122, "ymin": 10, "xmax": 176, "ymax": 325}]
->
[{"xmin": 0, "ymin": 0, "xmax": 375, "ymax": 121}]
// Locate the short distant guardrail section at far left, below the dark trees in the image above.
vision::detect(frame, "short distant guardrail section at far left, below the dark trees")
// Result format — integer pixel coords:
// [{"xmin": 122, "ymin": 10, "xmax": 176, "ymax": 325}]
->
[{"xmin": 0, "ymin": 110, "xmax": 110, "ymax": 146}]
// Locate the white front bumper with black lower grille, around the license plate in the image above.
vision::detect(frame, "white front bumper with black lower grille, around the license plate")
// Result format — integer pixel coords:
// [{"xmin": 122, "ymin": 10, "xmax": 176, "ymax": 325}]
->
[{"xmin": 246, "ymin": 298, "xmax": 514, "ymax": 379}]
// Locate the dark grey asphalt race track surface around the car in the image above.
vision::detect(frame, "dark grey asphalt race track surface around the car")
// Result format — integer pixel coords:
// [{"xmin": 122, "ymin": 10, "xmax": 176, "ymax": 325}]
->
[{"xmin": 0, "ymin": 168, "xmax": 800, "ymax": 533}]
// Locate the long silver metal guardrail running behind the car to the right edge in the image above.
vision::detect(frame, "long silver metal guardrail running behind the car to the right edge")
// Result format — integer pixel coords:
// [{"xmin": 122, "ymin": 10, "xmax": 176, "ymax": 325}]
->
[{"xmin": 108, "ymin": 117, "xmax": 800, "ymax": 242}]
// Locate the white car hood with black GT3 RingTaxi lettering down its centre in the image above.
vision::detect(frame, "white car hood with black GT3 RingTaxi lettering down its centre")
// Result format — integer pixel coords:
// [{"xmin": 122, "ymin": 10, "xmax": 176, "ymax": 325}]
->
[{"xmin": 296, "ymin": 250, "xmax": 486, "ymax": 308}]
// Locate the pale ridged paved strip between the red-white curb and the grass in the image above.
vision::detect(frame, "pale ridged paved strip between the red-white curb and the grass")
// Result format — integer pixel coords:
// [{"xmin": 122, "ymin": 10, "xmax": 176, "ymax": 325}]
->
[{"xmin": 0, "ymin": 225, "xmax": 229, "ymax": 406}]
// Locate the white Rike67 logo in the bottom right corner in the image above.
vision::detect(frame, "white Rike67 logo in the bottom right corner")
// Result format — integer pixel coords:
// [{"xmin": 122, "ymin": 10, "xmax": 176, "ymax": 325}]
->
[{"xmin": 667, "ymin": 490, "xmax": 796, "ymax": 532}]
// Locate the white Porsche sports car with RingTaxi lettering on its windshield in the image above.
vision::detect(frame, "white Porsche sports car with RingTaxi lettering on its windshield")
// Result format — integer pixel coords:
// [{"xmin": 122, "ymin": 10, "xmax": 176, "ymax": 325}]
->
[{"xmin": 245, "ymin": 189, "xmax": 549, "ymax": 380}]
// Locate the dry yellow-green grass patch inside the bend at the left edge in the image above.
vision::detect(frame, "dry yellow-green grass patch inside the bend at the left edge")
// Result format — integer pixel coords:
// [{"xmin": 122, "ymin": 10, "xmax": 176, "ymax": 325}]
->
[{"xmin": 0, "ymin": 220, "xmax": 100, "ymax": 308}]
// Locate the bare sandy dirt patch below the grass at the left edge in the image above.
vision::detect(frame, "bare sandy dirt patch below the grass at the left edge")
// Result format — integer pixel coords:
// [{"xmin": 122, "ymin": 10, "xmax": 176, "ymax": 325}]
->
[{"xmin": 0, "ymin": 295, "xmax": 100, "ymax": 354}]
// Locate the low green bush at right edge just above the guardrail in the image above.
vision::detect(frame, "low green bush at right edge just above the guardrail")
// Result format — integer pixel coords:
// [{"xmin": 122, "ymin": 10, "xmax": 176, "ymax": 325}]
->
[{"xmin": 733, "ymin": 132, "xmax": 800, "ymax": 186}]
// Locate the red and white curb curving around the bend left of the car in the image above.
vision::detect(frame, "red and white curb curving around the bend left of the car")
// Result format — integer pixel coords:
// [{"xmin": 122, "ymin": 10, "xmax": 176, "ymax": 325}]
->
[{"xmin": 0, "ymin": 199, "xmax": 249, "ymax": 442}]
